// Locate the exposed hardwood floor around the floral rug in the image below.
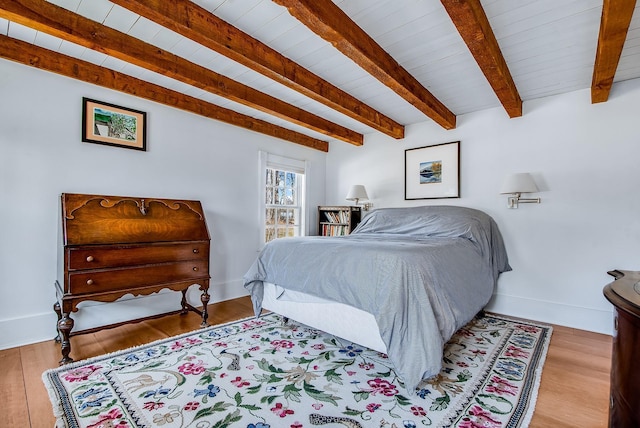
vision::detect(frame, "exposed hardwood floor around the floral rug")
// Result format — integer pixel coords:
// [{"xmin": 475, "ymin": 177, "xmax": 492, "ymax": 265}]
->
[{"xmin": 0, "ymin": 297, "xmax": 611, "ymax": 428}]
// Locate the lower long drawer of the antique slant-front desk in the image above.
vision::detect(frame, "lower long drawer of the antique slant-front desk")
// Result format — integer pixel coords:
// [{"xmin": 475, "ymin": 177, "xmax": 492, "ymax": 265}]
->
[{"xmin": 67, "ymin": 260, "xmax": 209, "ymax": 294}]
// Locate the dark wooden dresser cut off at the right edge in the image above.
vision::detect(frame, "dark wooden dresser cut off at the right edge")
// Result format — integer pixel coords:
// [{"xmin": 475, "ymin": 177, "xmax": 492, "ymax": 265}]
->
[{"xmin": 604, "ymin": 270, "xmax": 640, "ymax": 428}]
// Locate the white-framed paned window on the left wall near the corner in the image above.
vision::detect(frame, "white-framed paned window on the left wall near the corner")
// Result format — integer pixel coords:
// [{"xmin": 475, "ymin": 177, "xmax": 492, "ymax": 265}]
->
[{"xmin": 261, "ymin": 153, "xmax": 306, "ymax": 243}]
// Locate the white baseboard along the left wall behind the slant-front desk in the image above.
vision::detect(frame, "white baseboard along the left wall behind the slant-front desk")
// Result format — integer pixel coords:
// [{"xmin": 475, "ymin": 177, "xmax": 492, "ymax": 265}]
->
[{"xmin": 0, "ymin": 281, "xmax": 248, "ymax": 350}]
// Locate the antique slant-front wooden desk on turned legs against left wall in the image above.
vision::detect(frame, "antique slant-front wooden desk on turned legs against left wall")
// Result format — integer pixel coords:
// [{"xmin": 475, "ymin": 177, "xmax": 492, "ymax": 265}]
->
[{"xmin": 54, "ymin": 193, "xmax": 210, "ymax": 364}]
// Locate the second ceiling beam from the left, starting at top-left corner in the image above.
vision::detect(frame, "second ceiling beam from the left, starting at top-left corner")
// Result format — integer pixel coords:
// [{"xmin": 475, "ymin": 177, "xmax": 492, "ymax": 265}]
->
[{"xmin": 0, "ymin": 0, "xmax": 364, "ymax": 146}]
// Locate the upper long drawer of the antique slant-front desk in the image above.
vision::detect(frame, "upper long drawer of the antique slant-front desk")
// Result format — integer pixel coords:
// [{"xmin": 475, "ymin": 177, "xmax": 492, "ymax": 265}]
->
[{"xmin": 68, "ymin": 242, "xmax": 209, "ymax": 270}]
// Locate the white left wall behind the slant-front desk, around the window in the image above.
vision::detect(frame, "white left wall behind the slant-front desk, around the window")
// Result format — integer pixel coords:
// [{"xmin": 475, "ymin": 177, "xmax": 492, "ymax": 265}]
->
[{"xmin": 0, "ymin": 60, "xmax": 326, "ymax": 349}]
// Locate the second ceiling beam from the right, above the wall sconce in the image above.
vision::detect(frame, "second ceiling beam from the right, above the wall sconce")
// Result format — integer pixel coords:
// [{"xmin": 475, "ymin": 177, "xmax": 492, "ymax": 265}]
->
[{"xmin": 441, "ymin": 0, "xmax": 522, "ymax": 117}]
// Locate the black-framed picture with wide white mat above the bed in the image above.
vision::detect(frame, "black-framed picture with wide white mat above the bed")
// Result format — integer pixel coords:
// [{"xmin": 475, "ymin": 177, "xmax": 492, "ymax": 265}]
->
[{"xmin": 404, "ymin": 141, "xmax": 460, "ymax": 200}]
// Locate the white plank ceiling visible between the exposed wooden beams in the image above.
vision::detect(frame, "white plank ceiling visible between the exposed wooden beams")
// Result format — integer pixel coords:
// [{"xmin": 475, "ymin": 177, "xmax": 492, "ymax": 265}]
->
[{"xmin": 0, "ymin": 0, "xmax": 640, "ymax": 144}]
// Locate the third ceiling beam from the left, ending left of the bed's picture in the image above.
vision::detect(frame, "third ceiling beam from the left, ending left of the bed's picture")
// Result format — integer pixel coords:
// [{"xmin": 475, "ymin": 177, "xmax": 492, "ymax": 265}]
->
[{"xmin": 112, "ymin": 0, "xmax": 404, "ymax": 138}]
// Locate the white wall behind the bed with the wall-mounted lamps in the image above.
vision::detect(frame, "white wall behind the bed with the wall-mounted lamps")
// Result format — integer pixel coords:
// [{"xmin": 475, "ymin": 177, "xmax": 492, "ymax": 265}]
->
[{"xmin": 327, "ymin": 80, "xmax": 640, "ymax": 333}]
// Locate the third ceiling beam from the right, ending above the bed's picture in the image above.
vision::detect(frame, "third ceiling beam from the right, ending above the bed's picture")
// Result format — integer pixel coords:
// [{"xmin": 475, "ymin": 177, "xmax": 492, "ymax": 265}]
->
[{"xmin": 273, "ymin": 0, "xmax": 456, "ymax": 129}]
